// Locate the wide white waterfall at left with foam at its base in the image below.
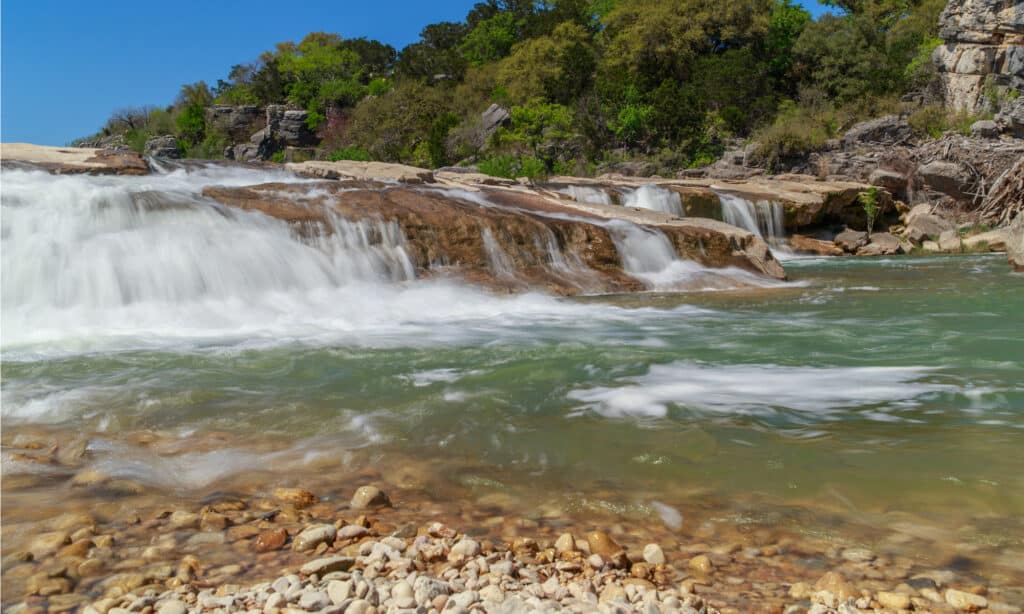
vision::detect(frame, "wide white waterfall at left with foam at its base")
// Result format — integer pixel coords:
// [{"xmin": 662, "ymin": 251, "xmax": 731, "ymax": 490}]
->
[{"xmin": 0, "ymin": 168, "xmax": 679, "ymax": 360}]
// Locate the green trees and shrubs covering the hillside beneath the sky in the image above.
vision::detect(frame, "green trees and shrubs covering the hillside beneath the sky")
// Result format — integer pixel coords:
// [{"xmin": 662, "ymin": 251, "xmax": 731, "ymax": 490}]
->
[{"xmin": 79, "ymin": 0, "xmax": 958, "ymax": 175}]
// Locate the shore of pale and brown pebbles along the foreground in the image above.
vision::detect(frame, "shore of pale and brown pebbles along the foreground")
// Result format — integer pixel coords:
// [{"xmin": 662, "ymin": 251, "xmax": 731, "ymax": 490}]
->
[{"xmin": 3, "ymin": 478, "xmax": 1021, "ymax": 614}]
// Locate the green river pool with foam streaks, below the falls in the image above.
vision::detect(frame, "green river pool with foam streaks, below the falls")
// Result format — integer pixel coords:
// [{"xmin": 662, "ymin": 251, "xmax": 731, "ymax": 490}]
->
[{"xmin": 3, "ymin": 257, "xmax": 1024, "ymax": 524}]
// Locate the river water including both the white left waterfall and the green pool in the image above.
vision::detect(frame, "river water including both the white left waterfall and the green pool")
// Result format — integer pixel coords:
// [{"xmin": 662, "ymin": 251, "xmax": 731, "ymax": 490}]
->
[{"xmin": 2, "ymin": 166, "xmax": 1024, "ymax": 577}]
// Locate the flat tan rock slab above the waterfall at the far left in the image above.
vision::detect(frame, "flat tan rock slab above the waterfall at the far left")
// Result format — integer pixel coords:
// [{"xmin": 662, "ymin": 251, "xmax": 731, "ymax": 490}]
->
[{"xmin": 0, "ymin": 143, "xmax": 150, "ymax": 175}]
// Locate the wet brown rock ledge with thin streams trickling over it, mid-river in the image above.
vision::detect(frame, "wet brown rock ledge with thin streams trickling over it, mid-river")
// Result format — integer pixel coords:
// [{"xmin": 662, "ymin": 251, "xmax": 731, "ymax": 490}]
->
[{"xmin": 204, "ymin": 180, "xmax": 784, "ymax": 295}]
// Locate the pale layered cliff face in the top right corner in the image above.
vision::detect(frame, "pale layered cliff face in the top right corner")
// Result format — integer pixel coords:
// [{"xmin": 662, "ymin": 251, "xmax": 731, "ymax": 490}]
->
[{"xmin": 932, "ymin": 0, "xmax": 1024, "ymax": 113}]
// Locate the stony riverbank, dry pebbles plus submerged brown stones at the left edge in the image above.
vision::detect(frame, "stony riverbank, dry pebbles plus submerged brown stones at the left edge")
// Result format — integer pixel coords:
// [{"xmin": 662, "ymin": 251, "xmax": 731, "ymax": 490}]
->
[{"xmin": 3, "ymin": 421, "xmax": 1024, "ymax": 614}]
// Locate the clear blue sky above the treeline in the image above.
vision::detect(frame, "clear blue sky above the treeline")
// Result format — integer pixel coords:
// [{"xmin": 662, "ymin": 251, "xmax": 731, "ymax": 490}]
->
[{"xmin": 0, "ymin": 0, "xmax": 821, "ymax": 145}]
